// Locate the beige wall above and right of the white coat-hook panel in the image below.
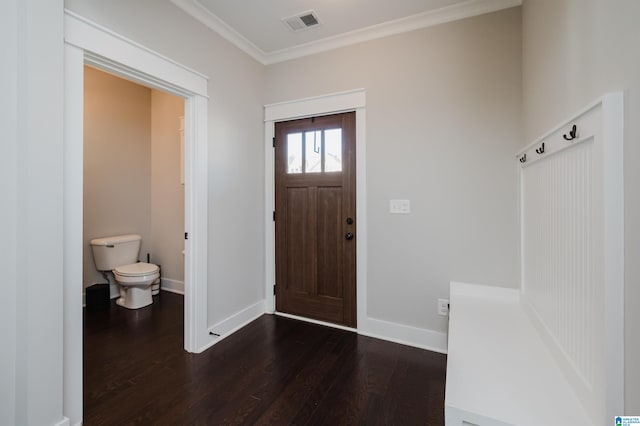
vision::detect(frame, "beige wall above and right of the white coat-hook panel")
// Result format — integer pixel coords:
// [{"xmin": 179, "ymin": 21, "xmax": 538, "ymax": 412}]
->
[{"xmin": 522, "ymin": 0, "xmax": 640, "ymax": 415}]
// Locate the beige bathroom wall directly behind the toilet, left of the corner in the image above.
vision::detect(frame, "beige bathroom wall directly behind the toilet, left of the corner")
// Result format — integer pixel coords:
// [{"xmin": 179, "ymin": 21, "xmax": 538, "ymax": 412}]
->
[{"xmin": 83, "ymin": 67, "xmax": 151, "ymax": 286}]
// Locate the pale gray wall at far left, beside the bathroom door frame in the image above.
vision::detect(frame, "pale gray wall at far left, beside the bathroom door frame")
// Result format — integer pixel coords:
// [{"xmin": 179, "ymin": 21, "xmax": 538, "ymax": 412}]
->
[{"xmin": 0, "ymin": 0, "xmax": 65, "ymax": 426}]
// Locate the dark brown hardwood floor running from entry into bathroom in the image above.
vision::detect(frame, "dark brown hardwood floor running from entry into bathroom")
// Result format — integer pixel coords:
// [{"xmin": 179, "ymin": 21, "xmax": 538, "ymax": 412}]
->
[{"xmin": 84, "ymin": 292, "xmax": 446, "ymax": 425}]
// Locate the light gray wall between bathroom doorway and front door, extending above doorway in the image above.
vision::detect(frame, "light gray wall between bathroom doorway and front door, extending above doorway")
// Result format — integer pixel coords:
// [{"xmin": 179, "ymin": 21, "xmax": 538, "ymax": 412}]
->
[{"xmin": 65, "ymin": 0, "xmax": 264, "ymax": 325}]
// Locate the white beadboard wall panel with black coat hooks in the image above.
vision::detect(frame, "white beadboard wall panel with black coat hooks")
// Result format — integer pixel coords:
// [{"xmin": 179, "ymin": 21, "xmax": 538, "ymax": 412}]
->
[{"xmin": 519, "ymin": 95, "xmax": 623, "ymax": 424}]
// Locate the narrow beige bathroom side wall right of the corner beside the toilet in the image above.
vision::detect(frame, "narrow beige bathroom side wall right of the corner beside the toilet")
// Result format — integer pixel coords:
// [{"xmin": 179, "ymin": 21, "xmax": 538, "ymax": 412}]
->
[{"xmin": 150, "ymin": 90, "xmax": 184, "ymax": 289}]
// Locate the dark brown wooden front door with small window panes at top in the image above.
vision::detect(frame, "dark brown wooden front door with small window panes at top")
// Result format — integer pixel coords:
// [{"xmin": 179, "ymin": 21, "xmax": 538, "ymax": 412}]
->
[{"xmin": 275, "ymin": 112, "xmax": 357, "ymax": 327}]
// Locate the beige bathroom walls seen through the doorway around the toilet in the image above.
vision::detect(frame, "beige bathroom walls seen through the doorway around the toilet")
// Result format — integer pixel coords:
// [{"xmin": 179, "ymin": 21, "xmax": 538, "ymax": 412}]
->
[{"xmin": 83, "ymin": 65, "xmax": 185, "ymax": 298}]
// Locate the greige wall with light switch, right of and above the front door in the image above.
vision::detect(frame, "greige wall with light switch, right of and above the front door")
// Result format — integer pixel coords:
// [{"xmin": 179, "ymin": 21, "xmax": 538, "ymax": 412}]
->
[{"xmin": 266, "ymin": 8, "xmax": 522, "ymax": 332}]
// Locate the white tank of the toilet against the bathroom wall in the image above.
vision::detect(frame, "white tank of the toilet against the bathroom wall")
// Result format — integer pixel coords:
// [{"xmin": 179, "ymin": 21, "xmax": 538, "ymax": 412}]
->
[{"xmin": 90, "ymin": 234, "xmax": 142, "ymax": 271}]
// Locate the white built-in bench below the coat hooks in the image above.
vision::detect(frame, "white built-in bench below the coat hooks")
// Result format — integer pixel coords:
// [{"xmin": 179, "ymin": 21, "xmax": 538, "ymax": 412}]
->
[{"xmin": 445, "ymin": 283, "xmax": 594, "ymax": 426}]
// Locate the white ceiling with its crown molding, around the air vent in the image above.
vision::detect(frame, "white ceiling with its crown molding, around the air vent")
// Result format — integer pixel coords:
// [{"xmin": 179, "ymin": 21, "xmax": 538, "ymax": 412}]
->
[{"xmin": 171, "ymin": 0, "xmax": 521, "ymax": 64}]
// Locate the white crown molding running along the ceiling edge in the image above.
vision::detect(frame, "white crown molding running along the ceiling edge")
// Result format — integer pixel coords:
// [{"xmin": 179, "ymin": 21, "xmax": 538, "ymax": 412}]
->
[{"xmin": 171, "ymin": 0, "xmax": 522, "ymax": 65}]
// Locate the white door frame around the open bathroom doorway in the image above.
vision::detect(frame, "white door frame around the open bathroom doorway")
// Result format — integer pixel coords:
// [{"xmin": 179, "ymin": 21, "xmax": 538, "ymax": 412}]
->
[{"xmin": 63, "ymin": 10, "xmax": 211, "ymax": 424}]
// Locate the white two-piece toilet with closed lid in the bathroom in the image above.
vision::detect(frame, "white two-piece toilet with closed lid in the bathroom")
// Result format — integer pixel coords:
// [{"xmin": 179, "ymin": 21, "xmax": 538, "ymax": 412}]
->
[{"xmin": 91, "ymin": 234, "xmax": 160, "ymax": 309}]
